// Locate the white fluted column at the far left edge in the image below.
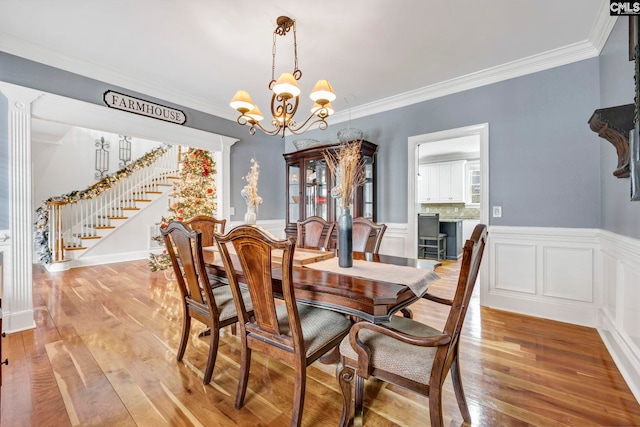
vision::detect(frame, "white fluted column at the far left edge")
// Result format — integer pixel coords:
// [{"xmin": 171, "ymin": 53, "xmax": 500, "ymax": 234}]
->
[{"xmin": 0, "ymin": 82, "xmax": 42, "ymax": 332}]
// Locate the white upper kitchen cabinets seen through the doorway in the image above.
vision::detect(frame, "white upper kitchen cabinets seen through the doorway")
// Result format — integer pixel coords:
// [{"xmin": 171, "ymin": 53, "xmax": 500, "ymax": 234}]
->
[{"xmin": 417, "ymin": 160, "xmax": 466, "ymax": 203}]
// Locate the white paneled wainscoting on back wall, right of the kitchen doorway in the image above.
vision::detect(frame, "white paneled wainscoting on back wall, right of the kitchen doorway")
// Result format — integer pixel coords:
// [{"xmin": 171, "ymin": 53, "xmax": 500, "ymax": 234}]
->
[{"xmin": 480, "ymin": 226, "xmax": 602, "ymax": 327}]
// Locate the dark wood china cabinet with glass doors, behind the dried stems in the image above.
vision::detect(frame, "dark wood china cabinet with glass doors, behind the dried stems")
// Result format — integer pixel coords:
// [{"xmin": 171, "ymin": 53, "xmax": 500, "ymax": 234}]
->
[{"xmin": 284, "ymin": 141, "xmax": 378, "ymax": 241}]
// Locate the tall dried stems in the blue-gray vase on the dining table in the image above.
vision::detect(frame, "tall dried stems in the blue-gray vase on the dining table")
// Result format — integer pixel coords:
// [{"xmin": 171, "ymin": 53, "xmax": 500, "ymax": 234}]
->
[{"xmin": 322, "ymin": 140, "xmax": 366, "ymax": 207}]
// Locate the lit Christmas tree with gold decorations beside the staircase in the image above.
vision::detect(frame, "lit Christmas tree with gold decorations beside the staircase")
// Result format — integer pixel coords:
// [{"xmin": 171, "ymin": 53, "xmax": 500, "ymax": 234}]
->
[{"xmin": 149, "ymin": 148, "xmax": 218, "ymax": 271}]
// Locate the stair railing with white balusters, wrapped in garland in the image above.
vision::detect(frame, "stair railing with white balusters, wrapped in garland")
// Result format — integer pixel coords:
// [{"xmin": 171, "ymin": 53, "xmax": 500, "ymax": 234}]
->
[{"xmin": 36, "ymin": 145, "xmax": 179, "ymax": 264}]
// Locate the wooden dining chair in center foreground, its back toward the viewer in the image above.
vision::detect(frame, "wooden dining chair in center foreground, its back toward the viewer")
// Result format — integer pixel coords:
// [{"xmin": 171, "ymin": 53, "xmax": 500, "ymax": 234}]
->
[{"xmin": 216, "ymin": 225, "xmax": 351, "ymax": 426}]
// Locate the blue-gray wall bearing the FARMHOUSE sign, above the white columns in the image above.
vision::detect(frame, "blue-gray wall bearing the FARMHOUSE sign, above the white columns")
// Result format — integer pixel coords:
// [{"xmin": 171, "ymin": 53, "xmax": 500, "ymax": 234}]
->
[{"xmin": 0, "ymin": 52, "xmax": 285, "ymax": 222}]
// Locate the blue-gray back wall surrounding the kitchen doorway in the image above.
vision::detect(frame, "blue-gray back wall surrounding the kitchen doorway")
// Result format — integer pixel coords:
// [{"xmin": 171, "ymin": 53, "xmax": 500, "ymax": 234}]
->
[{"xmin": 308, "ymin": 58, "xmax": 600, "ymax": 228}]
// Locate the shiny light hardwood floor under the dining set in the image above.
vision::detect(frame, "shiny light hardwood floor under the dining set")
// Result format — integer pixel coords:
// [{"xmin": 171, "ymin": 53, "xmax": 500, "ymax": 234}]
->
[{"xmin": 1, "ymin": 261, "xmax": 640, "ymax": 427}]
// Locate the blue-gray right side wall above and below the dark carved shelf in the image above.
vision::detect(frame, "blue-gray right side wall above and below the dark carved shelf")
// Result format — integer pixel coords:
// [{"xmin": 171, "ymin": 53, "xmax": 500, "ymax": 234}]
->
[{"xmin": 598, "ymin": 18, "xmax": 640, "ymax": 238}]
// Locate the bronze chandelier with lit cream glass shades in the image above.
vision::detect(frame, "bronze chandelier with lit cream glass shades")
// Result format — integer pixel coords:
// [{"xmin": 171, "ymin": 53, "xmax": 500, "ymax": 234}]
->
[{"xmin": 229, "ymin": 16, "xmax": 336, "ymax": 137}]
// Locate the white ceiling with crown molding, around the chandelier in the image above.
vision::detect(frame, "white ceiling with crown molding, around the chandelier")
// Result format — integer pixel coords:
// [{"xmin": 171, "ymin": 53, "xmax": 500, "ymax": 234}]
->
[{"xmin": 0, "ymin": 0, "xmax": 615, "ymax": 129}]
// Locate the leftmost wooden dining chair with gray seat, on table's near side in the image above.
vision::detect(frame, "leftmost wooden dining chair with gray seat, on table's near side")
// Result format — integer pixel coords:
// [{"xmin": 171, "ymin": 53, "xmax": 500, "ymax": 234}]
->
[{"xmin": 160, "ymin": 221, "xmax": 253, "ymax": 384}]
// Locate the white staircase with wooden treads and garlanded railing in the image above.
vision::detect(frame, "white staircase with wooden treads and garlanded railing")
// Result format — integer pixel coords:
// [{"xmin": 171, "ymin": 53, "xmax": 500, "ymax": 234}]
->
[{"xmin": 40, "ymin": 146, "xmax": 180, "ymax": 271}]
